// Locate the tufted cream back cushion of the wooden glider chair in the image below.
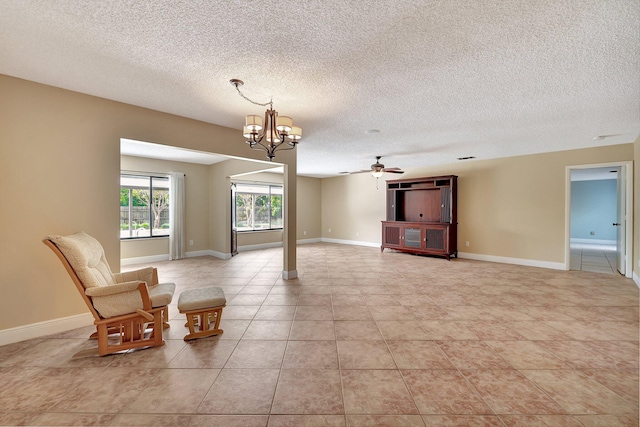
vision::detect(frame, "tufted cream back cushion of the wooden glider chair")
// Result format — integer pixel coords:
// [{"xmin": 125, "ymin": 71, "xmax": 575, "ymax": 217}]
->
[{"xmin": 47, "ymin": 232, "xmax": 116, "ymax": 289}]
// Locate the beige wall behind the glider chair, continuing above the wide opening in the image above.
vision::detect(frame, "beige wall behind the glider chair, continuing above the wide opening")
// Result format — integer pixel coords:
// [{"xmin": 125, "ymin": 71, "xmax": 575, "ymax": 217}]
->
[{"xmin": 0, "ymin": 75, "xmax": 296, "ymax": 330}]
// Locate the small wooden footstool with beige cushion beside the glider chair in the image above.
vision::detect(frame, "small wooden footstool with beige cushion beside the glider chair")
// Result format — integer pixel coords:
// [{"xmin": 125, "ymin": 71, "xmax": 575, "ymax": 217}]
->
[{"xmin": 178, "ymin": 287, "xmax": 227, "ymax": 341}]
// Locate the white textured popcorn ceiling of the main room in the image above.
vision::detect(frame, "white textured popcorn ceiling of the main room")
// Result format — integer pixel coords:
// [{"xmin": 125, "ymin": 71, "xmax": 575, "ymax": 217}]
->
[{"xmin": 0, "ymin": 0, "xmax": 640, "ymax": 176}]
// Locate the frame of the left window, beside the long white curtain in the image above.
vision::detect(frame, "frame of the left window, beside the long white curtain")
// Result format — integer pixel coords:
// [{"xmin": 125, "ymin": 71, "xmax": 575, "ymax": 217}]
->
[{"xmin": 119, "ymin": 171, "xmax": 171, "ymax": 240}]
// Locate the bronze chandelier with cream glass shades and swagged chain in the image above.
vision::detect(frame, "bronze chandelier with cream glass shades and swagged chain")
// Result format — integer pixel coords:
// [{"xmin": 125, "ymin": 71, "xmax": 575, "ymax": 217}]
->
[{"xmin": 230, "ymin": 79, "xmax": 302, "ymax": 161}]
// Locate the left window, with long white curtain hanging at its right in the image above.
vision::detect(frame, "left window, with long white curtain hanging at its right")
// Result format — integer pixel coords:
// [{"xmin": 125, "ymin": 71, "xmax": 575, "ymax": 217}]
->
[{"xmin": 120, "ymin": 175, "xmax": 169, "ymax": 239}]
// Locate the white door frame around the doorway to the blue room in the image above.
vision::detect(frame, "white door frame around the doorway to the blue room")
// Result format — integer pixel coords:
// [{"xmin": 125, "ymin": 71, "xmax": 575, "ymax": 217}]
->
[{"xmin": 564, "ymin": 161, "xmax": 633, "ymax": 278}]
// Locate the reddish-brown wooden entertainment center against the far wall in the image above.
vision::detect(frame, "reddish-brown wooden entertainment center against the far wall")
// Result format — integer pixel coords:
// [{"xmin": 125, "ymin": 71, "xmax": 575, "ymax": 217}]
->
[{"xmin": 380, "ymin": 175, "xmax": 458, "ymax": 259}]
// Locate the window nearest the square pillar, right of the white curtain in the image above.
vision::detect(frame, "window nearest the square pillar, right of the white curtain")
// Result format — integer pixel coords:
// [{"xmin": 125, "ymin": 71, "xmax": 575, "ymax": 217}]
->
[{"xmin": 235, "ymin": 183, "xmax": 283, "ymax": 231}]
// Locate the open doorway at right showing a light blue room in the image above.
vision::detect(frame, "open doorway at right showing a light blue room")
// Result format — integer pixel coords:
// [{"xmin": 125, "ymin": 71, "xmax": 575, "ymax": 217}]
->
[{"xmin": 565, "ymin": 162, "xmax": 633, "ymax": 277}]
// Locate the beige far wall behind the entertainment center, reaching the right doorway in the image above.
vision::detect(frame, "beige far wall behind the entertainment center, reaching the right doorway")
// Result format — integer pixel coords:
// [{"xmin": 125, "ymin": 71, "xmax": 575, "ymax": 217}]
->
[{"xmin": 322, "ymin": 144, "xmax": 637, "ymax": 263}]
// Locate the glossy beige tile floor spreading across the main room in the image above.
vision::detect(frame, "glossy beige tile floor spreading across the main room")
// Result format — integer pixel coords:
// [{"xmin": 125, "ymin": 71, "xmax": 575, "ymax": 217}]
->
[{"xmin": 0, "ymin": 244, "xmax": 639, "ymax": 427}]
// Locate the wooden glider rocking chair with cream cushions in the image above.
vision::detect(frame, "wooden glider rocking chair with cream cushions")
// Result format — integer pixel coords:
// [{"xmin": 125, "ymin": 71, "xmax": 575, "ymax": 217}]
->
[{"xmin": 43, "ymin": 232, "xmax": 175, "ymax": 356}]
